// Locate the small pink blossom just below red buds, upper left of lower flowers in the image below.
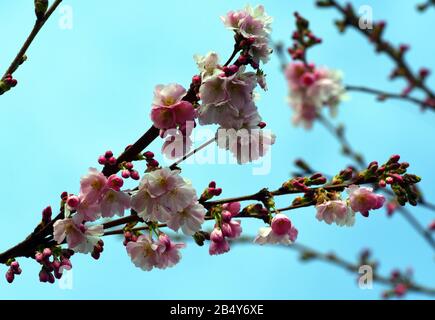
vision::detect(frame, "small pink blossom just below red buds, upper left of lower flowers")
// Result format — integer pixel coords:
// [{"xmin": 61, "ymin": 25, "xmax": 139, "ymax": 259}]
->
[{"xmin": 80, "ymin": 168, "xmax": 107, "ymax": 204}]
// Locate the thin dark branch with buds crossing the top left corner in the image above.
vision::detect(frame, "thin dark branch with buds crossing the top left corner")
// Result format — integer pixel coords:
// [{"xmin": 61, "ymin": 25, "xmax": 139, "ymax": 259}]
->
[{"xmin": 0, "ymin": 0, "xmax": 62, "ymax": 95}]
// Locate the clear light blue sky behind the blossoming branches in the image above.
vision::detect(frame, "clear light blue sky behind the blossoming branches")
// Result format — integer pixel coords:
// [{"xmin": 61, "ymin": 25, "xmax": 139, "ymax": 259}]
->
[{"xmin": 0, "ymin": 0, "xmax": 435, "ymax": 299}]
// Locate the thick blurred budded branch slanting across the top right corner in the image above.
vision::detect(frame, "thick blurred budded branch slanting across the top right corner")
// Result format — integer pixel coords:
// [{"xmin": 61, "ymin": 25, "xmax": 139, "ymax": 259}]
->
[{"xmin": 317, "ymin": 0, "xmax": 435, "ymax": 111}]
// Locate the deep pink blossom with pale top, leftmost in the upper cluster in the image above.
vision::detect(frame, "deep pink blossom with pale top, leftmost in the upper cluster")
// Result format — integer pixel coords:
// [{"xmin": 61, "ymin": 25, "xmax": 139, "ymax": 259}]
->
[{"xmin": 151, "ymin": 84, "xmax": 195, "ymax": 129}]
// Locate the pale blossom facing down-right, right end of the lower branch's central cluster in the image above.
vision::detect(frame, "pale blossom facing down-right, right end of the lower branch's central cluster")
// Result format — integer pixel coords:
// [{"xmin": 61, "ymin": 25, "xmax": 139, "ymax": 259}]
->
[{"xmin": 167, "ymin": 201, "xmax": 206, "ymax": 235}]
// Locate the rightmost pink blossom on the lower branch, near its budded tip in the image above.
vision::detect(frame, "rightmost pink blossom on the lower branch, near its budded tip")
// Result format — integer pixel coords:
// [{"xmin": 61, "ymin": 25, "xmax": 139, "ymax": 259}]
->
[{"xmin": 347, "ymin": 185, "xmax": 385, "ymax": 217}]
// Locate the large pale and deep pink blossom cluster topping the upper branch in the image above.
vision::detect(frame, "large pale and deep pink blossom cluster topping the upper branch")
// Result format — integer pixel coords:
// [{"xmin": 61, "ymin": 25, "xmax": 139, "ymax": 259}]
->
[{"xmin": 151, "ymin": 6, "xmax": 275, "ymax": 163}]
